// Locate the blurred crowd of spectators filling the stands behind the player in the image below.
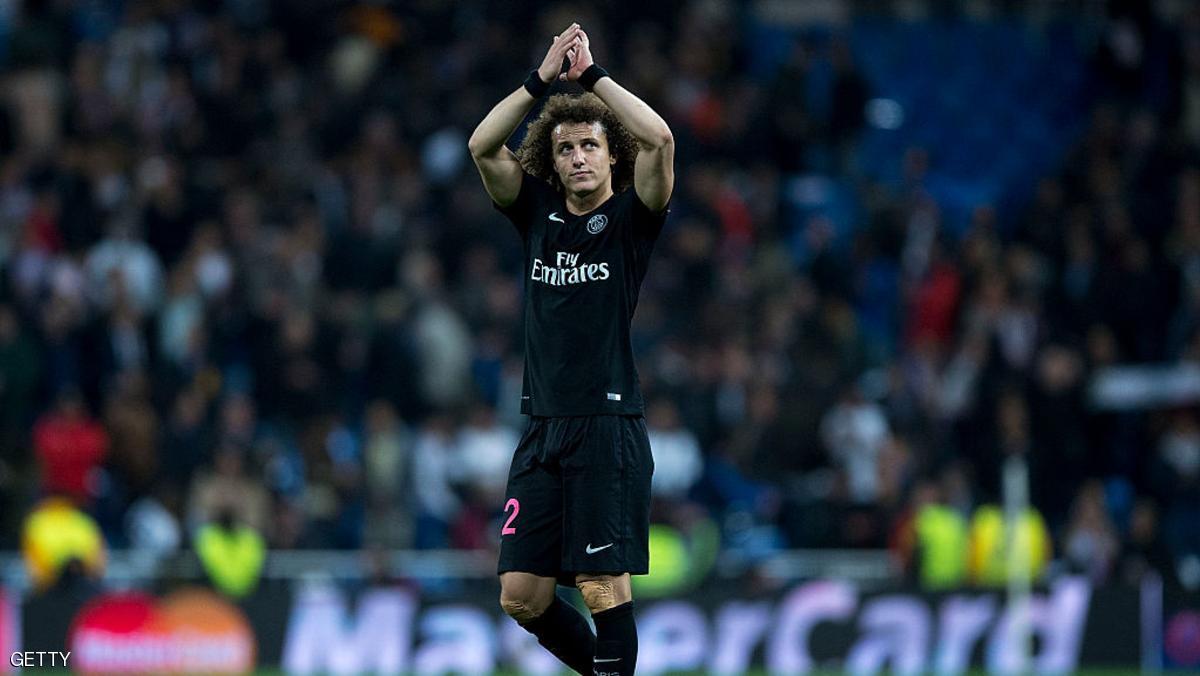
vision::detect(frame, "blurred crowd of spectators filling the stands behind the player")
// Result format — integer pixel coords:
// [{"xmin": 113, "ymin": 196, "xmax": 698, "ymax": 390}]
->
[{"xmin": 0, "ymin": 0, "xmax": 1200, "ymax": 593}]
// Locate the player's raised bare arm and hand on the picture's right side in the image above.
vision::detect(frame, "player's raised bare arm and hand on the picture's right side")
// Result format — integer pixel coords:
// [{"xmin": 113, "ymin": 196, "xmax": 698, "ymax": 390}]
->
[{"xmin": 560, "ymin": 30, "xmax": 674, "ymax": 211}]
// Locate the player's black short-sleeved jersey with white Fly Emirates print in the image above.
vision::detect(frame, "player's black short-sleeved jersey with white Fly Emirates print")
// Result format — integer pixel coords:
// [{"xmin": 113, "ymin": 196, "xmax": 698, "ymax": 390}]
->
[{"xmin": 496, "ymin": 174, "xmax": 667, "ymax": 417}]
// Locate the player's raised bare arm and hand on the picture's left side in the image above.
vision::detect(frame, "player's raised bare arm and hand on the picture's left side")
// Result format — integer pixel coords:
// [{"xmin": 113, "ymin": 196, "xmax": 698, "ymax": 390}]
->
[{"xmin": 467, "ymin": 24, "xmax": 582, "ymax": 207}]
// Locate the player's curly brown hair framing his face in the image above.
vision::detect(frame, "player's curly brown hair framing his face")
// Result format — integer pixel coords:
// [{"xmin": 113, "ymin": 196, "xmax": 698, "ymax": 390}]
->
[{"xmin": 517, "ymin": 94, "xmax": 637, "ymax": 192}]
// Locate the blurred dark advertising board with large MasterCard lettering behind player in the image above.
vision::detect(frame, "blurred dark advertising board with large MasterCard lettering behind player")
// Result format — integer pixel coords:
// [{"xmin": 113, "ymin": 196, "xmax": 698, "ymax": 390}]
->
[{"xmin": 11, "ymin": 578, "xmax": 1180, "ymax": 675}]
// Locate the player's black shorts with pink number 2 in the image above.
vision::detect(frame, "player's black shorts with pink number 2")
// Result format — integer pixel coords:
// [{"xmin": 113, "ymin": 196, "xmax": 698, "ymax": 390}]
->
[{"xmin": 498, "ymin": 415, "xmax": 654, "ymax": 586}]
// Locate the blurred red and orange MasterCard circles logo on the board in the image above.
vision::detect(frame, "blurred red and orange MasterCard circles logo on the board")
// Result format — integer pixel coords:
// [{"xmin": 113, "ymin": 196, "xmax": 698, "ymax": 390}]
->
[{"xmin": 70, "ymin": 590, "xmax": 254, "ymax": 674}]
